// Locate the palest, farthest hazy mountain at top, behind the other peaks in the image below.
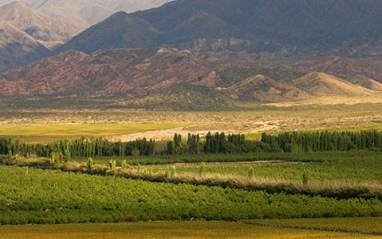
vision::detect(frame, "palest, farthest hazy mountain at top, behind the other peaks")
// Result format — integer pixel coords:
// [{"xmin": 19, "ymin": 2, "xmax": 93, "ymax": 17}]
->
[{"xmin": 0, "ymin": 0, "xmax": 172, "ymax": 26}]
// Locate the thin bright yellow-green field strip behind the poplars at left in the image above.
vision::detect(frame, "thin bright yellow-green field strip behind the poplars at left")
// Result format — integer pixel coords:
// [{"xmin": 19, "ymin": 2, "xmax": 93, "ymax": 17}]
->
[{"xmin": 0, "ymin": 123, "xmax": 195, "ymax": 143}]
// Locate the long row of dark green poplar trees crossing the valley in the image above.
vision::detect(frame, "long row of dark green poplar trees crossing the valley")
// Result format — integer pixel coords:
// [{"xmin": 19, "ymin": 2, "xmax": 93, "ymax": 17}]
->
[{"xmin": 0, "ymin": 131, "xmax": 382, "ymax": 161}]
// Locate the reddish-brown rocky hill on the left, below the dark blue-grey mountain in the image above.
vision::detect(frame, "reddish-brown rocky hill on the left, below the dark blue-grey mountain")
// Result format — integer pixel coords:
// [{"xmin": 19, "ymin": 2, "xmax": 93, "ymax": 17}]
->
[{"xmin": 0, "ymin": 49, "xmax": 215, "ymax": 97}]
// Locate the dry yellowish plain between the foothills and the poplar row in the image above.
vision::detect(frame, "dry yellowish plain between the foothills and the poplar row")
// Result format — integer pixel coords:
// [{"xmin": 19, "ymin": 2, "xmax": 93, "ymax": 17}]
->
[{"xmin": 0, "ymin": 104, "xmax": 382, "ymax": 142}]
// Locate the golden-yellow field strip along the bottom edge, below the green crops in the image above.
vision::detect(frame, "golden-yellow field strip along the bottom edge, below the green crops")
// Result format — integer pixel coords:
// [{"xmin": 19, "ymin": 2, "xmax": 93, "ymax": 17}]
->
[{"xmin": 0, "ymin": 222, "xmax": 381, "ymax": 239}]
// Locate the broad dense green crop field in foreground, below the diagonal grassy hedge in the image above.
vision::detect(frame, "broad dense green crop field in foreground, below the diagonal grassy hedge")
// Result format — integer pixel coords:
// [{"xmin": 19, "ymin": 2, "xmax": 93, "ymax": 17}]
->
[{"xmin": 0, "ymin": 166, "xmax": 382, "ymax": 224}]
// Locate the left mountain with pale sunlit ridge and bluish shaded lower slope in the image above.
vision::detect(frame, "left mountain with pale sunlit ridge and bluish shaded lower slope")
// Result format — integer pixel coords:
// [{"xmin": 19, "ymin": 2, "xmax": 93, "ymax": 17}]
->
[{"xmin": 0, "ymin": 2, "xmax": 85, "ymax": 70}]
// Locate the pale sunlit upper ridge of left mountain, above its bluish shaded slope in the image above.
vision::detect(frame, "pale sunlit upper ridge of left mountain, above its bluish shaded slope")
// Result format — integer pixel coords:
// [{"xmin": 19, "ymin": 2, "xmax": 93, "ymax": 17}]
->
[{"xmin": 0, "ymin": 2, "xmax": 85, "ymax": 48}]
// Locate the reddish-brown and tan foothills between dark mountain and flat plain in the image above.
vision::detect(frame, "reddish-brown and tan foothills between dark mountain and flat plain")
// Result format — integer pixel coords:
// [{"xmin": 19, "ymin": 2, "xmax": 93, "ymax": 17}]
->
[{"xmin": 0, "ymin": 48, "xmax": 382, "ymax": 109}]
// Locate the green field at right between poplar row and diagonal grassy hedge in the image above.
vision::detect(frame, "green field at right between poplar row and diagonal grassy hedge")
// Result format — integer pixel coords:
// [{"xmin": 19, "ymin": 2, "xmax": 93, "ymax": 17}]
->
[{"xmin": 145, "ymin": 152, "xmax": 382, "ymax": 183}]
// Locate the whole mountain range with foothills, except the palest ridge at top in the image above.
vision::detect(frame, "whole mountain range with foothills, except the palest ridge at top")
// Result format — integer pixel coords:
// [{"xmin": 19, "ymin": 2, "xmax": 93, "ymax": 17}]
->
[{"xmin": 0, "ymin": 0, "xmax": 382, "ymax": 109}]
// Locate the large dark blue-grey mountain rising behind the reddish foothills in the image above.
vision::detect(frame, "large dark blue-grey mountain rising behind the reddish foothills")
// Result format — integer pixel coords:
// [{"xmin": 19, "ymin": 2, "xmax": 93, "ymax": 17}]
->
[{"xmin": 61, "ymin": 0, "xmax": 382, "ymax": 56}]
